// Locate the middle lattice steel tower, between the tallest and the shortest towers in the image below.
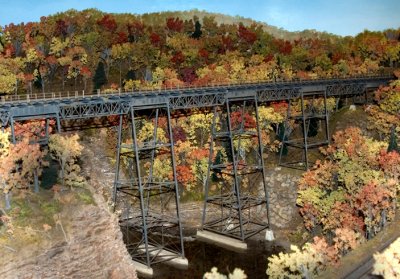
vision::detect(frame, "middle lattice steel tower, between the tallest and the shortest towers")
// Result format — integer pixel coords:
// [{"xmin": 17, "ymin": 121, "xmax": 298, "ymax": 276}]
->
[{"xmin": 202, "ymin": 97, "xmax": 269, "ymax": 241}]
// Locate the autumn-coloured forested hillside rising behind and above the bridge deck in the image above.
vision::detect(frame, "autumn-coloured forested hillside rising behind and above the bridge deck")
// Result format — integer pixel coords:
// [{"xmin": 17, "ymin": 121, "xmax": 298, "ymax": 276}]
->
[{"xmin": 0, "ymin": 9, "xmax": 400, "ymax": 93}]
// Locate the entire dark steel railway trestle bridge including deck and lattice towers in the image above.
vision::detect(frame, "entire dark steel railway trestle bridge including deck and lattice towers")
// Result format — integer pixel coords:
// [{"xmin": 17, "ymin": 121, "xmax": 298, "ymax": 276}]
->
[{"xmin": 0, "ymin": 76, "xmax": 393, "ymax": 273}]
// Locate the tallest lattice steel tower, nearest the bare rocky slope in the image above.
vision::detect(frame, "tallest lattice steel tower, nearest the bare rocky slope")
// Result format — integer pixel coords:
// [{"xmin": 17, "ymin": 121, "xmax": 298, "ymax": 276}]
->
[{"xmin": 113, "ymin": 104, "xmax": 187, "ymax": 268}]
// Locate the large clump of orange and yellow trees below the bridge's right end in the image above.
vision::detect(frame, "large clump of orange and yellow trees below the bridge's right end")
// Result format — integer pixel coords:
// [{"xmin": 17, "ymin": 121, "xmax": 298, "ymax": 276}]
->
[{"xmin": 297, "ymin": 128, "xmax": 400, "ymax": 238}]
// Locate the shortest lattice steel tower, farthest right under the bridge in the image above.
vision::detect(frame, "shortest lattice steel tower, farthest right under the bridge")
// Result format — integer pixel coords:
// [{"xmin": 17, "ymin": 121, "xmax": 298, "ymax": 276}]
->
[{"xmin": 279, "ymin": 90, "xmax": 330, "ymax": 170}]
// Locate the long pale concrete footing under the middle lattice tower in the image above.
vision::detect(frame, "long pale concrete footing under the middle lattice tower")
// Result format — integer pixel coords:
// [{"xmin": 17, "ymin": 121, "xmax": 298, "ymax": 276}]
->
[{"xmin": 196, "ymin": 230, "xmax": 247, "ymax": 252}]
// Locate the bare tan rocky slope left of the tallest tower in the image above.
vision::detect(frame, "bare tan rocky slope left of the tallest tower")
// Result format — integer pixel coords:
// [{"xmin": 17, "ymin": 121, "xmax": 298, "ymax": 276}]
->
[{"xmin": 0, "ymin": 131, "xmax": 137, "ymax": 279}]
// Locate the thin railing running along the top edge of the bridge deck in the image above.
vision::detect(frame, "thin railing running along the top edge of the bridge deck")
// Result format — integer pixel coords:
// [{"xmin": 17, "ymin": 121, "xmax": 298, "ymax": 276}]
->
[{"xmin": 0, "ymin": 75, "xmax": 393, "ymax": 104}]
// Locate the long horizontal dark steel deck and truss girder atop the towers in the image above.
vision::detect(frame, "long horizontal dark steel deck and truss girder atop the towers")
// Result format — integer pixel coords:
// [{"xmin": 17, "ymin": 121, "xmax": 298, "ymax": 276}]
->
[{"xmin": 0, "ymin": 76, "xmax": 393, "ymax": 127}]
